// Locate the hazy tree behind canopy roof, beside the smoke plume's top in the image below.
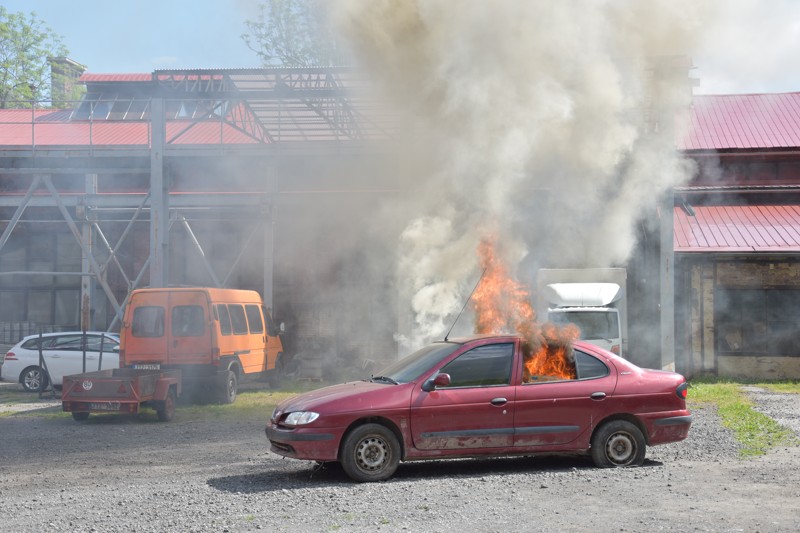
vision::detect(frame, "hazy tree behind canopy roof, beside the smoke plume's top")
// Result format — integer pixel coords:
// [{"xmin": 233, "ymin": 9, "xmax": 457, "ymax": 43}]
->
[{"xmin": 242, "ymin": 0, "xmax": 348, "ymax": 67}]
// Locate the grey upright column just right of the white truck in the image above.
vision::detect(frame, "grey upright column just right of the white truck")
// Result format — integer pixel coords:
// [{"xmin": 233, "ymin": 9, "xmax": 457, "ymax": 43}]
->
[{"xmin": 660, "ymin": 190, "xmax": 675, "ymax": 371}]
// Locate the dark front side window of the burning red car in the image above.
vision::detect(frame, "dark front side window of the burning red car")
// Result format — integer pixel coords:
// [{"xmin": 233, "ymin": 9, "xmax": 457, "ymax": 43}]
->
[{"xmin": 440, "ymin": 343, "xmax": 514, "ymax": 388}]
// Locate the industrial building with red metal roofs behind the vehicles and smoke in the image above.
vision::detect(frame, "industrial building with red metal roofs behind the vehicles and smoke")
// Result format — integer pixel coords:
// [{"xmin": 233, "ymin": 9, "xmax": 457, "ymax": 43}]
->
[{"xmin": 0, "ymin": 63, "xmax": 800, "ymax": 378}]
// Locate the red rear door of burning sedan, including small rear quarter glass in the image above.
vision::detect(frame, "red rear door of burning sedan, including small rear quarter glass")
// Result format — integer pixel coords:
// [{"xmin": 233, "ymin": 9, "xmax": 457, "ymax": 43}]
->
[{"xmin": 514, "ymin": 350, "xmax": 617, "ymax": 447}]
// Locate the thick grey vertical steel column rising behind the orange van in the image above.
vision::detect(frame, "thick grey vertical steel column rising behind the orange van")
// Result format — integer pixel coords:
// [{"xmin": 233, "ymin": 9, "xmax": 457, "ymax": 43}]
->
[{"xmin": 150, "ymin": 98, "xmax": 169, "ymax": 287}]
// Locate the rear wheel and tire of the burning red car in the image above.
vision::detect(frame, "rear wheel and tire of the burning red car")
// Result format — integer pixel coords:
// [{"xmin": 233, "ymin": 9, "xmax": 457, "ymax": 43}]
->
[{"xmin": 592, "ymin": 420, "xmax": 647, "ymax": 468}]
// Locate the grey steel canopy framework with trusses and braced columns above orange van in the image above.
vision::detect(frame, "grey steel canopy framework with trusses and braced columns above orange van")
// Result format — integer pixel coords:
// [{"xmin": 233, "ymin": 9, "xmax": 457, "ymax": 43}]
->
[{"xmin": 0, "ymin": 68, "xmax": 392, "ymax": 329}]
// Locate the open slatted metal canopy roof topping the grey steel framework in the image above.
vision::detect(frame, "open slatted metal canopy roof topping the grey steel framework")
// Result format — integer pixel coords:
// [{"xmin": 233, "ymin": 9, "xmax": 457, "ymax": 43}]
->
[{"xmin": 73, "ymin": 68, "xmax": 393, "ymax": 144}]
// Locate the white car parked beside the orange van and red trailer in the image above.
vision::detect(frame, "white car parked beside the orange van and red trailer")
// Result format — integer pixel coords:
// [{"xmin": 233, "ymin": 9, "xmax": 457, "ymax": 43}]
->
[{"xmin": 0, "ymin": 331, "xmax": 119, "ymax": 391}]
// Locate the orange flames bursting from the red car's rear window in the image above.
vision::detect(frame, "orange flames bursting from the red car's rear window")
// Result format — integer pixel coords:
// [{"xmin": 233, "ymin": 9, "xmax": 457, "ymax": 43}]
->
[{"xmin": 472, "ymin": 239, "xmax": 580, "ymax": 383}]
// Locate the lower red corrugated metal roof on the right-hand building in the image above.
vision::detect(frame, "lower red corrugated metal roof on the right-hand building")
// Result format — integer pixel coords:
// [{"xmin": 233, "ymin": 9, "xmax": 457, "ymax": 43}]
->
[{"xmin": 674, "ymin": 205, "xmax": 800, "ymax": 253}]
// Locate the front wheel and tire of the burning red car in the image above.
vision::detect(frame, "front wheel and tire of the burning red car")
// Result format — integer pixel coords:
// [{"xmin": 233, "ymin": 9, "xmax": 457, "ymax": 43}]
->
[{"xmin": 339, "ymin": 424, "xmax": 400, "ymax": 482}]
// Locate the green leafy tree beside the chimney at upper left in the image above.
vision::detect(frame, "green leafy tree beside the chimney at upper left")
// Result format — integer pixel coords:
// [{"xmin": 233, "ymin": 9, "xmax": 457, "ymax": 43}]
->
[{"xmin": 0, "ymin": 6, "xmax": 68, "ymax": 109}]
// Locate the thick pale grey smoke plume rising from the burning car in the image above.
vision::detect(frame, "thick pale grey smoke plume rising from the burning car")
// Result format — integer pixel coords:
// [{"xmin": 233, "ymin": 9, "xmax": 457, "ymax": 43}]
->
[{"xmin": 339, "ymin": 0, "xmax": 704, "ymax": 345}]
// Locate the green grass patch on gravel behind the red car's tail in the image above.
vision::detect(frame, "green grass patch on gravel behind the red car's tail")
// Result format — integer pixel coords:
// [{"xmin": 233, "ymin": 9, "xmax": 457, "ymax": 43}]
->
[{"xmin": 689, "ymin": 379, "xmax": 798, "ymax": 457}]
